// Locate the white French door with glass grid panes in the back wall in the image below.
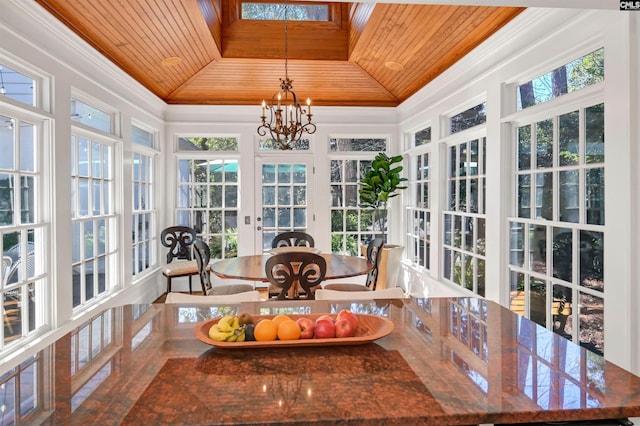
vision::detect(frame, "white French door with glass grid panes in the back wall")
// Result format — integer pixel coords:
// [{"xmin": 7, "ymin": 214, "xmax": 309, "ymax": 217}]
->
[{"xmin": 255, "ymin": 155, "xmax": 314, "ymax": 253}]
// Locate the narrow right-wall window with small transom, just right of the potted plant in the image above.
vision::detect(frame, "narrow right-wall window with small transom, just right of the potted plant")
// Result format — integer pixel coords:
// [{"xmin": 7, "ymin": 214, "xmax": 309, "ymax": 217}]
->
[{"xmin": 407, "ymin": 127, "xmax": 431, "ymax": 269}]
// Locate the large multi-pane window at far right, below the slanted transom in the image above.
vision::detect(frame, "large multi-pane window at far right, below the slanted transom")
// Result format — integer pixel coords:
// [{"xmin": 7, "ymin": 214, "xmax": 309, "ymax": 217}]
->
[{"xmin": 509, "ymin": 104, "xmax": 605, "ymax": 354}]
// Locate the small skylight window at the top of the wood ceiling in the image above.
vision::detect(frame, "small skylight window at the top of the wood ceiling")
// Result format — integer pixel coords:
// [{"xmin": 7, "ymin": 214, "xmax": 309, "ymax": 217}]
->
[{"xmin": 242, "ymin": 2, "xmax": 329, "ymax": 21}]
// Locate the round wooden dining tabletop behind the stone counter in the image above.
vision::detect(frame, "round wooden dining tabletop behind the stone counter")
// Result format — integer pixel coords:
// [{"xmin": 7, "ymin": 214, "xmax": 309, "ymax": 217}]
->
[{"xmin": 211, "ymin": 253, "xmax": 373, "ymax": 282}]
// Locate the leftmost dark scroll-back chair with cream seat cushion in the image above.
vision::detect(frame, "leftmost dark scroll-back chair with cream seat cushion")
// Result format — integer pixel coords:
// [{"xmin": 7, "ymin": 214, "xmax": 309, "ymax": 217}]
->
[{"xmin": 160, "ymin": 226, "xmax": 198, "ymax": 294}]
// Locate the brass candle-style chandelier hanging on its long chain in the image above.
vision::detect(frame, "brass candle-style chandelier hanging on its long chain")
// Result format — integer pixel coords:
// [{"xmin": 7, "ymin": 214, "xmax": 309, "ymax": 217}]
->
[{"xmin": 258, "ymin": 0, "xmax": 316, "ymax": 150}]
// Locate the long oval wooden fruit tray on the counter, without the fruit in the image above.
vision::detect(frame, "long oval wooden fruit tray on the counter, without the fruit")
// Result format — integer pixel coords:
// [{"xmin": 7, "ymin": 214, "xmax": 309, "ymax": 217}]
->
[{"xmin": 194, "ymin": 314, "xmax": 393, "ymax": 349}]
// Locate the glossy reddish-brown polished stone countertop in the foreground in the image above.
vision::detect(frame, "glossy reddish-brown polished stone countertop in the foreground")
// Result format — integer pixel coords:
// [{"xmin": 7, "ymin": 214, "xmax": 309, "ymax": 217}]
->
[{"xmin": 36, "ymin": 298, "xmax": 640, "ymax": 425}]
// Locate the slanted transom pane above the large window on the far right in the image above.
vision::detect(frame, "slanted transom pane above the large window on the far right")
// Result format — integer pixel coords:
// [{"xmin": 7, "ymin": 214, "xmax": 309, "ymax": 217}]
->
[{"xmin": 516, "ymin": 48, "xmax": 604, "ymax": 110}]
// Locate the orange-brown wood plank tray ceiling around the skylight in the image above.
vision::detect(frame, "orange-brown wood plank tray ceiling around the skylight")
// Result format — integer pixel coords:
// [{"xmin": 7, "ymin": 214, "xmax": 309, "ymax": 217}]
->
[{"xmin": 36, "ymin": 0, "xmax": 524, "ymax": 106}]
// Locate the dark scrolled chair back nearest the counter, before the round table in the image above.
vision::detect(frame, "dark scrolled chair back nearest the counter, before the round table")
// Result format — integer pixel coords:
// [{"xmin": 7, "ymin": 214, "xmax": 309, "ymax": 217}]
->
[{"xmin": 265, "ymin": 252, "xmax": 327, "ymax": 300}]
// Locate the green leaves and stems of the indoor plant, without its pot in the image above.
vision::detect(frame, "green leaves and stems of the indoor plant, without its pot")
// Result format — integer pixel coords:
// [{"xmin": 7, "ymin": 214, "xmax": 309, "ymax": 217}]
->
[{"xmin": 358, "ymin": 152, "xmax": 407, "ymax": 242}]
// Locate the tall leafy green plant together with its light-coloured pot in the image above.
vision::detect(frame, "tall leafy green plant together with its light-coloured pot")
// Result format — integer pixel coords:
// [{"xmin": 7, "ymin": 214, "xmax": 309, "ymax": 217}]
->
[{"xmin": 359, "ymin": 152, "xmax": 407, "ymax": 289}]
